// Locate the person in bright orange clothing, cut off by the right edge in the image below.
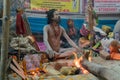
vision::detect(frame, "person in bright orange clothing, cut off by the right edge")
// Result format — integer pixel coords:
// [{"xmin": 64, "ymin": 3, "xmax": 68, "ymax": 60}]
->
[{"xmin": 109, "ymin": 40, "xmax": 120, "ymax": 60}]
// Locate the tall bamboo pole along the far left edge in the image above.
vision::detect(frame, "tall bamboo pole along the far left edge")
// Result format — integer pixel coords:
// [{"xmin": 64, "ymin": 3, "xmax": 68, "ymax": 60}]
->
[{"xmin": 0, "ymin": 0, "xmax": 10, "ymax": 80}]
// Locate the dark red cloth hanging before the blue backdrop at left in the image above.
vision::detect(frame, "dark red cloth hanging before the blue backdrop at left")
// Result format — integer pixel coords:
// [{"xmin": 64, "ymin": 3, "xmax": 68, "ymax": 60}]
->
[{"xmin": 16, "ymin": 13, "xmax": 26, "ymax": 35}]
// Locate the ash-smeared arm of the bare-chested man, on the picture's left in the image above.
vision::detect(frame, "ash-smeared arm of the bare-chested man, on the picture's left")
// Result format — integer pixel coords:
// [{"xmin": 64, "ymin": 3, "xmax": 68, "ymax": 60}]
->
[{"xmin": 43, "ymin": 26, "xmax": 52, "ymax": 51}]
